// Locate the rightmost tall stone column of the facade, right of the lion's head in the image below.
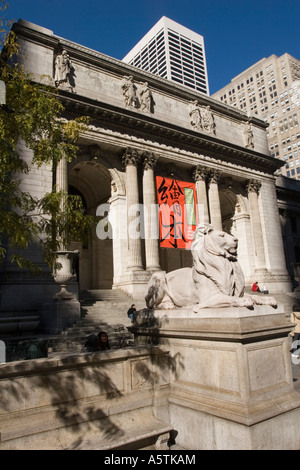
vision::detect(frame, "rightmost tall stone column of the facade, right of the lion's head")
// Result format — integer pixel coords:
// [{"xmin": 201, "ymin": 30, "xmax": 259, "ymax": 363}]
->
[{"xmin": 247, "ymin": 180, "xmax": 266, "ymax": 272}]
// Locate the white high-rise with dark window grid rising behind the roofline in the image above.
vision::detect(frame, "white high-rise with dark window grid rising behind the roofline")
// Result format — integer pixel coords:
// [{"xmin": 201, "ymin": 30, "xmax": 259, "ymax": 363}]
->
[{"xmin": 123, "ymin": 16, "xmax": 209, "ymax": 95}]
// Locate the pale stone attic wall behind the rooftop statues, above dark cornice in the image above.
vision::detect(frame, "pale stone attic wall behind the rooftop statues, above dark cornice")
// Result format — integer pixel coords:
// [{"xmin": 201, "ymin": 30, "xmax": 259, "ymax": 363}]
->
[{"xmin": 15, "ymin": 20, "xmax": 269, "ymax": 155}]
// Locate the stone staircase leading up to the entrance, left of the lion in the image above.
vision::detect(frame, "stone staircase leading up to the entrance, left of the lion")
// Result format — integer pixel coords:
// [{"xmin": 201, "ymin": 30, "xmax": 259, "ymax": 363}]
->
[{"xmin": 48, "ymin": 289, "xmax": 145, "ymax": 357}]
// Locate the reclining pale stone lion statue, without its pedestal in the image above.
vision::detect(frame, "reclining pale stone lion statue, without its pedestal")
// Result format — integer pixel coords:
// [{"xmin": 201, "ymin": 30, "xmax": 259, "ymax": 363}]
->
[{"xmin": 145, "ymin": 225, "xmax": 277, "ymax": 312}]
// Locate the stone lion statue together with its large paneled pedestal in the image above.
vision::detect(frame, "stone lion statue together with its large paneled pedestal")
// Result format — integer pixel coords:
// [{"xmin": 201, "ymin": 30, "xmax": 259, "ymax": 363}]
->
[{"xmin": 131, "ymin": 226, "xmax": 300, "ymax": 450}]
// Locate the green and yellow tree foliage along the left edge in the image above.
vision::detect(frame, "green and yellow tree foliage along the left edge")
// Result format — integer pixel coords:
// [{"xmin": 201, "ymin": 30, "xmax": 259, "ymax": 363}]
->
[{"xmin": 0, "ymin": 0, "xmax": 93, "ymax": 268}]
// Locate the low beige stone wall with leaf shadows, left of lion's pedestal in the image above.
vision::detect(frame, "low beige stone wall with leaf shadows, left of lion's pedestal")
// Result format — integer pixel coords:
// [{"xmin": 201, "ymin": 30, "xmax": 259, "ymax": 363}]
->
[{"xmin": 0, "ymin": 347, "xmax": 172, "ymax": 450}]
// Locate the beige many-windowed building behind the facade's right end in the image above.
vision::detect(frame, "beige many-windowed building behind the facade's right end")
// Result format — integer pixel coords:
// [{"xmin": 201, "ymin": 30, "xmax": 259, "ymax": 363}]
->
[{"xmin": 212, "ymin": 53, "xmax": 300, "ymax": 180}]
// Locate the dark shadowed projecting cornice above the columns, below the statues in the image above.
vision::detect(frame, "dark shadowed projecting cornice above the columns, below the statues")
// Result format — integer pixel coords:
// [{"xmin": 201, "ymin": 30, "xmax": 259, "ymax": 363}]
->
[{"xmin": 59, "ymin": 91, "xmax": 282, "ymax": 174}]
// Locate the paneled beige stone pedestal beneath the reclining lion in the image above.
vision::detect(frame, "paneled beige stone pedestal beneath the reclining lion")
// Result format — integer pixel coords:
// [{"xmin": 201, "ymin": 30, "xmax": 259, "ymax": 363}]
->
[{"xmin": 131, "ymin": 305, "xmax": 300, "ymax": 450}]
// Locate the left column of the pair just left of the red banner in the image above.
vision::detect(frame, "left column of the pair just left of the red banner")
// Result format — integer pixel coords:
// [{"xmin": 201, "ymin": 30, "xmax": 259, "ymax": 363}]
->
[{"xmin": 124, "ymin": 148, "xmax": 143, "ymax": 271}]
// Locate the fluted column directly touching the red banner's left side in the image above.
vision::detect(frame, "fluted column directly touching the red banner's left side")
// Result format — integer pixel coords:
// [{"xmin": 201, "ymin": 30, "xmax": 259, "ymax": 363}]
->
[{"xmin": 143, "ymin": 153, "xmax": 161, "ymax": 271}]
